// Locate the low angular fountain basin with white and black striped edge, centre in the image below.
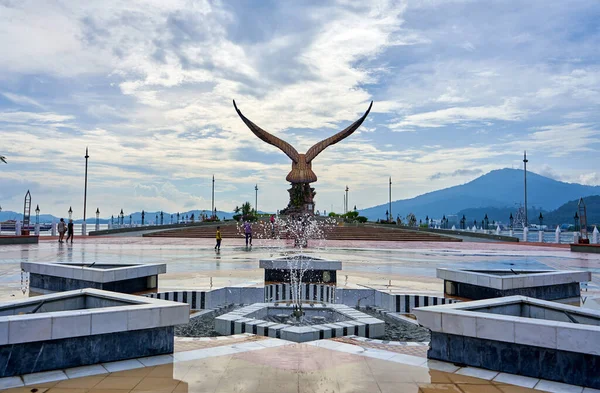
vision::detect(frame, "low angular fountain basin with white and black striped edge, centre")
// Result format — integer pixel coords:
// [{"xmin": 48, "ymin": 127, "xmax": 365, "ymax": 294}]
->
[{"xmin": 215, "ymin": 303, "xmax": 385, "ymax": 343}]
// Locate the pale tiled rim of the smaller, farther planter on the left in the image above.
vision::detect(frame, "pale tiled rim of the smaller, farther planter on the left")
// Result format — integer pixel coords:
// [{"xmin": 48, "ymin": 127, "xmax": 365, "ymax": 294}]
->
[{"xmin": 21, "ymin": 262, "xmax": 167, "ymax": 283}]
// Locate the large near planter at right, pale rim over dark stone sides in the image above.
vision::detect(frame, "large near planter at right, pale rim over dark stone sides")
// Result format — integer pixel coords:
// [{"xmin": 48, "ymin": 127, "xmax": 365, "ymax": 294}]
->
[{"xmin": 413, "ymin": 296, "xmax": 600, "ymax": 389}]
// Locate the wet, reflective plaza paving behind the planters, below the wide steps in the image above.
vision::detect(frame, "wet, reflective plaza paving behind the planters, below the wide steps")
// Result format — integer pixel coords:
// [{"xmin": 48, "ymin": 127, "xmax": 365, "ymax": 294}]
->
[{"xmin": 0, "ymin": 236, "xmax": 600, "ymax": 308}]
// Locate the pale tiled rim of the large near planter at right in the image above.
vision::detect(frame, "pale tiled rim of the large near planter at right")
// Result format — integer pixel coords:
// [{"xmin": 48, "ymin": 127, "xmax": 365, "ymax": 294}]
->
[{"xmin": 413, "ymin": 295, "xmax": 600, "ymax": 355}]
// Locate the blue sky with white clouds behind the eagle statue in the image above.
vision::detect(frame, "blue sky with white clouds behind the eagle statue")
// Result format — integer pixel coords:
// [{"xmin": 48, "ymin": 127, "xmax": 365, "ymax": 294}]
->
[{"xmin": 0, "ymin": 0, "xmax": 600, "ymax": 217}]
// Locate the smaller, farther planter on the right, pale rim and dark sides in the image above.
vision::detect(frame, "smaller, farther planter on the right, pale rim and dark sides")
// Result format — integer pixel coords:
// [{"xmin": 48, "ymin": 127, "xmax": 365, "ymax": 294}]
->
[{"xmin": 437, "ymin": 268, "xmax": 592, "ymax": 304}]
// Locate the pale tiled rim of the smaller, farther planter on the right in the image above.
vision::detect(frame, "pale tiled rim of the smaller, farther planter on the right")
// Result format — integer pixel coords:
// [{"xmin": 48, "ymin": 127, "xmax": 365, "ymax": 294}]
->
[{"xmin": 436, "ymin": 268, "xmax": 592, "ymax": 290}]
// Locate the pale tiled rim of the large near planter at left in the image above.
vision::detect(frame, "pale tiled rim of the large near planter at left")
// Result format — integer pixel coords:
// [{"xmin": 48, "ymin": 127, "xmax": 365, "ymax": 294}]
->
[{"xmin": 0, "ymin": 288, "xmax": 189, "ymax": 346}]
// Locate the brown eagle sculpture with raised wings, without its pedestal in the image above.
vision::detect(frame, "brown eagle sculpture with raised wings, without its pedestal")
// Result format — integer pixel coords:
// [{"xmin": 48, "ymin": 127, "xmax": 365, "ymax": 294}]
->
[{"xmin": 233, "ymin": 100, "xmax": 373, "ymax": 184}]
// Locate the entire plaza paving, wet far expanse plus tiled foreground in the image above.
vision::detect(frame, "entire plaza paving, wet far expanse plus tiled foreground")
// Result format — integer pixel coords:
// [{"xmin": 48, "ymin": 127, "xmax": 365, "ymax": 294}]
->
[{"xmin": 0, "ymin": 236, "xmax": 600, "ymax": 393}]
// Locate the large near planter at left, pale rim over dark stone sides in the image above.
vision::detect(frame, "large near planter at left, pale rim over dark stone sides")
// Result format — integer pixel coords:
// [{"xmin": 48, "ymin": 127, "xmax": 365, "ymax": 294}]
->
[{"xmin": 0, "ymin": 289, "xmax": 189, "ymax": 377}]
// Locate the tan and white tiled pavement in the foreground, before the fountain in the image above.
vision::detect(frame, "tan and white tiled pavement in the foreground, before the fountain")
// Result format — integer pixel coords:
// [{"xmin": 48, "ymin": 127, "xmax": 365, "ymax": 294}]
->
[{"xmin": 0, "ymin": 335, "xmax": 599, "ymax": 393}]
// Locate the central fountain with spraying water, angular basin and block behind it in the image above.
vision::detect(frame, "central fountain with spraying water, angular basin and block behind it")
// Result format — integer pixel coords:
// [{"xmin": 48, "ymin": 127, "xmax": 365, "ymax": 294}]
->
[{"xmin": 215, "ymin": 214, "xmax": 384, "ymax": 342}]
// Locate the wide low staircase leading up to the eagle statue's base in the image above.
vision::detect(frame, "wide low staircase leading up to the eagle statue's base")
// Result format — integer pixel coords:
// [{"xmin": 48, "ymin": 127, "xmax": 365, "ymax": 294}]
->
[{"xmin": 144, "ymin": 223, "xmax": 462, "ymax": 242}]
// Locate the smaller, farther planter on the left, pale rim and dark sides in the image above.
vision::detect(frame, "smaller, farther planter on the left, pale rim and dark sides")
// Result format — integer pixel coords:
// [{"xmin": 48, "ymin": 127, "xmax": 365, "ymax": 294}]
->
[{"xmin": 21, "ymin": 262, "xmax": 167, "ymax": 293}]
